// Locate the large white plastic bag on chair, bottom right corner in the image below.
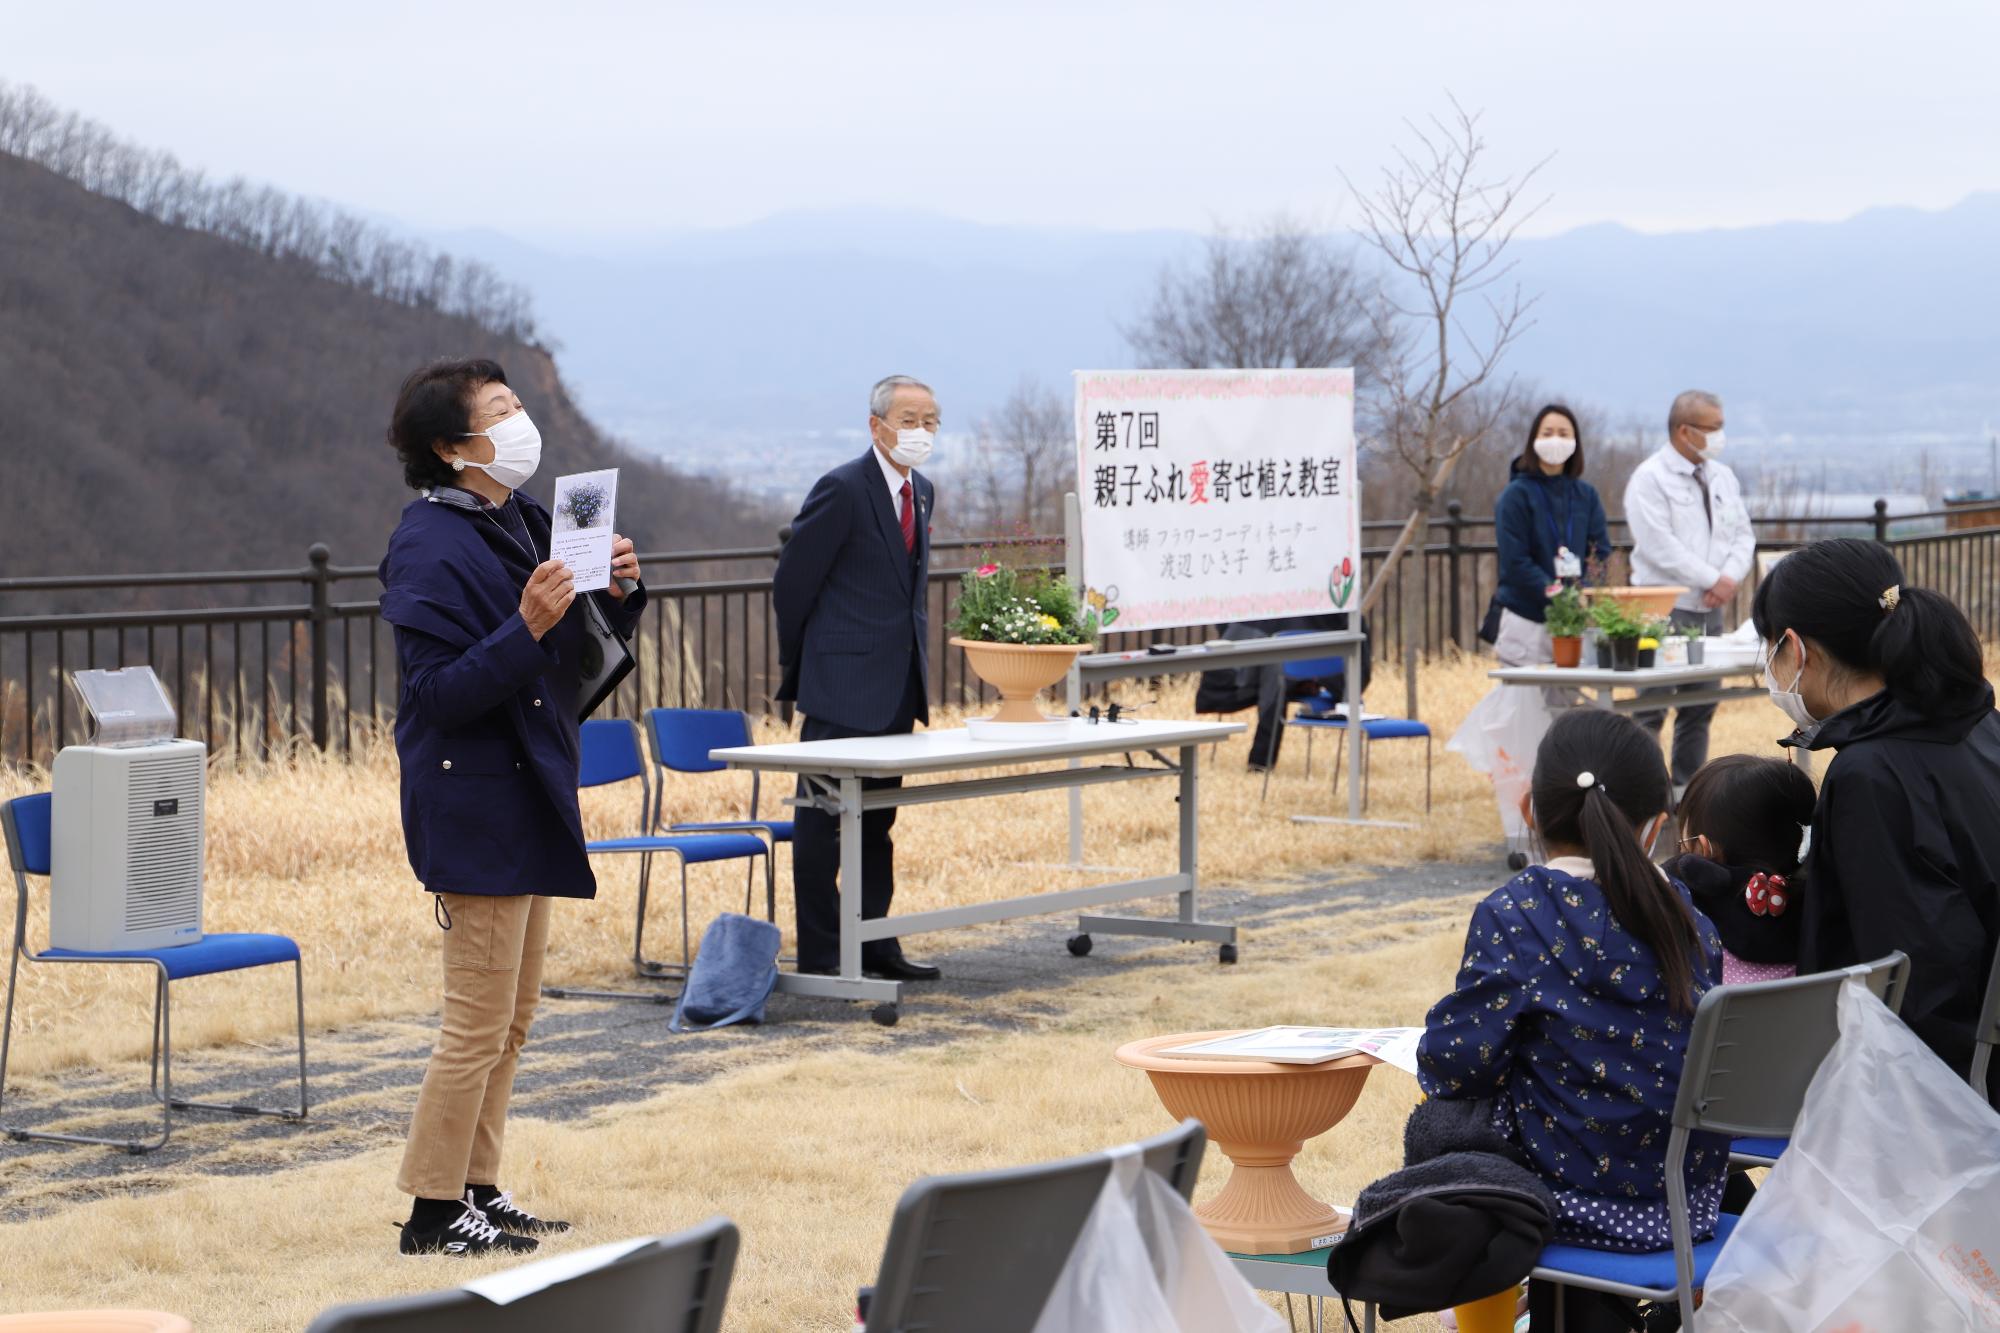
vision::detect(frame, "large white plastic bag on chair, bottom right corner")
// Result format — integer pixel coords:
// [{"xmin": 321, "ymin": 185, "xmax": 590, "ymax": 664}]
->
[{"xmin": 1696, "ymin": 981, "xmax": 2000, "ymax": 1333}]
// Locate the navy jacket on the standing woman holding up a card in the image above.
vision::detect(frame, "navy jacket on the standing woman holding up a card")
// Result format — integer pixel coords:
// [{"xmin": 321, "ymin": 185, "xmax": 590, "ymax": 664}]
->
[{"xmin": 380, "ymin": 482, "xmax": 646, "ymax": 899}]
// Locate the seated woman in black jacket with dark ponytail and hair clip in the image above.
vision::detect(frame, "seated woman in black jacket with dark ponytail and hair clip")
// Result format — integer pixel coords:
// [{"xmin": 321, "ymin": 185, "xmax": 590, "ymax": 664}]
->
[{"xmin": 1752, "ymin": 538, "xmax": 2000, "ymax": 1093}]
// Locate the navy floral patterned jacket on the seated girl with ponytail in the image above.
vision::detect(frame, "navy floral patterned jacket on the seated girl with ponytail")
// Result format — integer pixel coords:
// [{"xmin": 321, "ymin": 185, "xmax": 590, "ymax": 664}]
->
[{"xmin": 1418, "ymin": 857, "xmax": 1728, "ymax": 1251}]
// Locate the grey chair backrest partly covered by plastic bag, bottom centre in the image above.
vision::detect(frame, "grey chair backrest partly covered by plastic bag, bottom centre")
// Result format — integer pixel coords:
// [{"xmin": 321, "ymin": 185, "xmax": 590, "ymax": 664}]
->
[{"xmin": 866, "ymin": 1119, "xmax": 1208, "ymax": 1333}]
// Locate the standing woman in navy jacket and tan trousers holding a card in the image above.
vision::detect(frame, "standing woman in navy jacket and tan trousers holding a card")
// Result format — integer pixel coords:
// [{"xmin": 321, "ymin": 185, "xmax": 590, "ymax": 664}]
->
[{"xmin": 380, "ymin": 360, "xmax": 646, "ymax": 1255}]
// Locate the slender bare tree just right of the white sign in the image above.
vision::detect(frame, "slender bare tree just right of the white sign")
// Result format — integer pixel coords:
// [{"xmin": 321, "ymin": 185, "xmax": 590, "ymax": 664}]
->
[{"xmin": 1342, "ymin": 98, "xmax": 1548, "ymax": 610}]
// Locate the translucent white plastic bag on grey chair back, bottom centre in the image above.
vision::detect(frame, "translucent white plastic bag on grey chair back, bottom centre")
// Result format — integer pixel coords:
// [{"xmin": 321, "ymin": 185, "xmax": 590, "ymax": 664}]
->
[{"xmin": 1034, "ymin": 1149, "xmax": 1284, "ymax": 1333}]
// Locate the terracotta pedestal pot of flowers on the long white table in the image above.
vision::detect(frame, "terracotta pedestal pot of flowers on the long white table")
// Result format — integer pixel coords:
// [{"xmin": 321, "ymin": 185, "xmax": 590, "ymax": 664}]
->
[{"xmin": 952, "ymin": 560, "xmax": 1098, "ymax": 741}]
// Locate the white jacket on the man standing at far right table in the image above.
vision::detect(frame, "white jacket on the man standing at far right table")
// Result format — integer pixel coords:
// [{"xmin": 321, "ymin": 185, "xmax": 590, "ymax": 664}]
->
[{"xmin": 1626, "ymin": 444, "xmax": 1756, "ymax": 610}]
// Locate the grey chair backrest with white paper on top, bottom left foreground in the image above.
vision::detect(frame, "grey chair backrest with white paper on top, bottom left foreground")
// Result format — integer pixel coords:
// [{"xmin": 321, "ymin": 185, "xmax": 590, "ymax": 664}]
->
[{"xmin": 306, "ymin": 1217, "xmax": 738, "ymax": 1333}]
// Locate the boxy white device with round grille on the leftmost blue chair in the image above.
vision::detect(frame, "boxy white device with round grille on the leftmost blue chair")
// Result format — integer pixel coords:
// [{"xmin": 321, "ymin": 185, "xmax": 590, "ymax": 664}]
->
[{"xmin": 48, "ymin": 667, "xmax": 208, "ymax": 953}]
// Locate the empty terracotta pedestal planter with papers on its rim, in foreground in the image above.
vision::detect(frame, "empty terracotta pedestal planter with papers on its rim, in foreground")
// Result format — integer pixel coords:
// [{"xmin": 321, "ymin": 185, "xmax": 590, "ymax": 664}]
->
[{"xmin": 1116, "ymin": 1033, "xmax": 1380, "ymax": 1255}]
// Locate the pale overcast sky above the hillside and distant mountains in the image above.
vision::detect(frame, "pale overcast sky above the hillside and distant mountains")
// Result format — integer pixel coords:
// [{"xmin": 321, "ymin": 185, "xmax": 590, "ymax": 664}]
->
[{"xmin": 0, "ymin": 0, "xmax": 2000, "ymax": 234}]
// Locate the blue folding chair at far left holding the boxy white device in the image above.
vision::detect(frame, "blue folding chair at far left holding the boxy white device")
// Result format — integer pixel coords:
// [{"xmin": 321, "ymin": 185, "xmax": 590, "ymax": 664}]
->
[{"xmin": 0, "ymin": 793, "xmax": 308, "ymax": 1153}]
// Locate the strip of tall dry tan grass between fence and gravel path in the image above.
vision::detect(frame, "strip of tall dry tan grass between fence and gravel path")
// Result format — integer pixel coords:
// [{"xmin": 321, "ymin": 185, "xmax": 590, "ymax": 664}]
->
[{"xmin": 0, "ymin": 658, "xmax": 1816, "ymax": 1073}]
